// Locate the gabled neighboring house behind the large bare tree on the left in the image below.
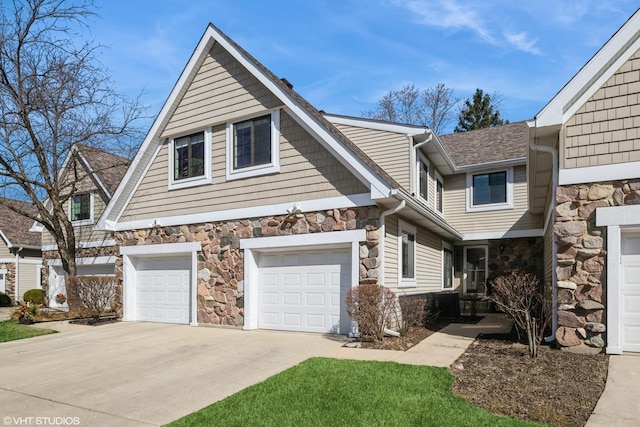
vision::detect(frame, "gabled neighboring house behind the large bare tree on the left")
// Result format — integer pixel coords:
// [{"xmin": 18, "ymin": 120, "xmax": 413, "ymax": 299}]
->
[{"xmin": 39, "ymin": 145, "xmax": 129, "ymax": 307}]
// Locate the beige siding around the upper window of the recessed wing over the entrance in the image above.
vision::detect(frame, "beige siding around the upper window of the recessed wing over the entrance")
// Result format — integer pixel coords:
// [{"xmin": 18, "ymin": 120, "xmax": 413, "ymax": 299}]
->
[{"xmin": 444, "ymin": 165, "xmax": 543, "ymax": 237}]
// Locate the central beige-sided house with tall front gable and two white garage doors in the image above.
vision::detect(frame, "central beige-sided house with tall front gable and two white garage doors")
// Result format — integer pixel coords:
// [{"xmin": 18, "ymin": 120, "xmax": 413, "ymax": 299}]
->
[{"xmin": 95, "ymin": 25, "xmax": 543, "ymax": 334}]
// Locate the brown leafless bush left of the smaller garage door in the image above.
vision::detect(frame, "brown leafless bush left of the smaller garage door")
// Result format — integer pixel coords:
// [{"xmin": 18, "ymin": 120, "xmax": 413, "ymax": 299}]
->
[{"xmin": 70, "ymin": 276, "xmax": 116, "ymax": 319}]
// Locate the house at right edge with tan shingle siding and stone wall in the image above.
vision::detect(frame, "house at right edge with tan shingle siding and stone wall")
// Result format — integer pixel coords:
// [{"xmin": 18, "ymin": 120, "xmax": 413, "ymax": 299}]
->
[{"xmin": 528, "ymin": 10, "xmax": 640, "ymax": 354}]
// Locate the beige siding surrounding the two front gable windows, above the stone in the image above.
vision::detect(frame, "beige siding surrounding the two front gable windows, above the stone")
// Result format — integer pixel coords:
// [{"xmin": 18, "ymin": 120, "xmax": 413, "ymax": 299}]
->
[{"xmin": 120, "ymin": 111, "xmax": 369, "ymax": 221}]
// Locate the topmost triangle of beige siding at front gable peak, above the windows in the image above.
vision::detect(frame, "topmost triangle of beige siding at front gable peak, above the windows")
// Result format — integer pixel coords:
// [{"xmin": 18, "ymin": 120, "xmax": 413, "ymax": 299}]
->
[{"xmin": 162, "ymin": 44, "xmax": 282, "ymax": 138}]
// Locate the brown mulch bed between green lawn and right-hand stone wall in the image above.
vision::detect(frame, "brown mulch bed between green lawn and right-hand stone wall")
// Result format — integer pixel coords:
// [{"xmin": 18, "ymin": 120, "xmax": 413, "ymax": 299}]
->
[{"xmin": 450, "ymin": 335, "xmax": 609, "ymax": 427}]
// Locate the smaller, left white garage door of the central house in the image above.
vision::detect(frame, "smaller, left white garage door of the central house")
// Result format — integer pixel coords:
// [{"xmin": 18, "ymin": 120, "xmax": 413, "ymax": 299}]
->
[{"xmin": 136, "ymin": 257, "xmax": 191, "ymax": 324}]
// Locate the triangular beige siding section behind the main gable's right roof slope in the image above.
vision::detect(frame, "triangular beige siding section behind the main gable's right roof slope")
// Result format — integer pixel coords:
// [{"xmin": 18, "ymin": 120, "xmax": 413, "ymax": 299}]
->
[{"xmin": 335, "ymin": 124, "xmax": 411, "ymax": 190}]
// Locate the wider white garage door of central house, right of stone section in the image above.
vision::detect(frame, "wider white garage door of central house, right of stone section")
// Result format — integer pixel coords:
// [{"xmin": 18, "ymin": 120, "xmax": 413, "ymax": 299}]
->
[{"xmin": 258, "ymin": 250, "xmax": 351, "ymax": 334}]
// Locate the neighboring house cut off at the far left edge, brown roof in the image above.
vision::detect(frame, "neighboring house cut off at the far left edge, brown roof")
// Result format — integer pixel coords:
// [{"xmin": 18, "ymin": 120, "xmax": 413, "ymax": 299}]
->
[{"xmin": 0, "ymin": 199, "xmax": 42, "ymax": 303}]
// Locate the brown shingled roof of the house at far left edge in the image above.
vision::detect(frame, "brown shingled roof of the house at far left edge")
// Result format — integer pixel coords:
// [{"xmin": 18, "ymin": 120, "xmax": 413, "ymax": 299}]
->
[{"xmin": 0, "ymin": 198, "xmax": 42, "ymax": 247}]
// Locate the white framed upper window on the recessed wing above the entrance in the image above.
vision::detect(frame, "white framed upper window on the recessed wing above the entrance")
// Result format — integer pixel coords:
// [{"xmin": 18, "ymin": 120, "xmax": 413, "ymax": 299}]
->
[{"xmin": 467, "ymin": 168, "xmax": 513, "ymax": 212}]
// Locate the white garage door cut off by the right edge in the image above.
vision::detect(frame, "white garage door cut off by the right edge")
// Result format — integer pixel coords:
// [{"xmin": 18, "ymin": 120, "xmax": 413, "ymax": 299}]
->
[{"xmin": 620, "ymin": 233, "xmax": 640, "ymax": 352}]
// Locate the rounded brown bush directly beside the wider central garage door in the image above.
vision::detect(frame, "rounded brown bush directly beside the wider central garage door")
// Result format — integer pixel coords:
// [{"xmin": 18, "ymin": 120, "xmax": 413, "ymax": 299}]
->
[{"xmin": 346, "ymin": 284, "xmax": 396, "ymax": 341}]
